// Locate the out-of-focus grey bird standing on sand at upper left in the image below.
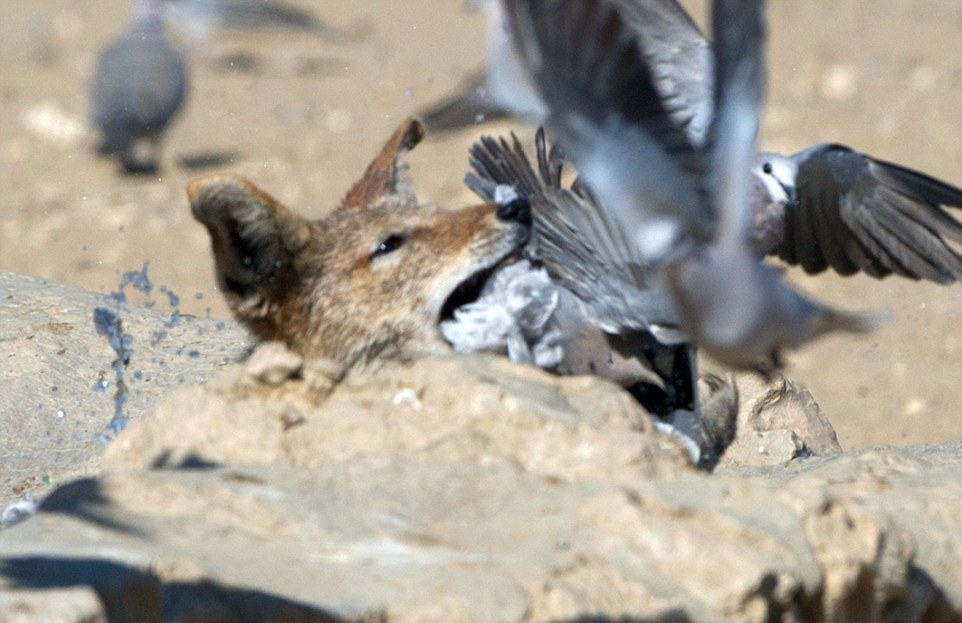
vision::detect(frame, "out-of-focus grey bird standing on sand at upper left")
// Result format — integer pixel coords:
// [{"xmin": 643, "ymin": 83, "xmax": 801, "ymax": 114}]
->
[{"xmin": 90, "ymin": 0, "xmax": 187, "ymax": 173}]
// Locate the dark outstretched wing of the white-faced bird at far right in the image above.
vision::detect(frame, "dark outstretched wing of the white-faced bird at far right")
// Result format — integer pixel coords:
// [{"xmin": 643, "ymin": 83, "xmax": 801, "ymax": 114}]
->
[{"xmin": 772, "ymin": 144, "xmax": 962, "ymax": 283}]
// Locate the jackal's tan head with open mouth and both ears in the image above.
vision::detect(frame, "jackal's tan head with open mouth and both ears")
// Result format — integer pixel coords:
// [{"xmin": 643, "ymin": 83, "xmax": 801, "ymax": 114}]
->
[{"xmin": 187, "ymin": 120, "xmax": 531, "ymax": 367}]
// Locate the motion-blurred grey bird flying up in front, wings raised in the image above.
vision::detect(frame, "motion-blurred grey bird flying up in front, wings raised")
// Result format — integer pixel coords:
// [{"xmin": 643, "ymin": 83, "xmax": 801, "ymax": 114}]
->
[{"xmin": 488, "ymin": 0, "xmax": 874, "ymax": 368}]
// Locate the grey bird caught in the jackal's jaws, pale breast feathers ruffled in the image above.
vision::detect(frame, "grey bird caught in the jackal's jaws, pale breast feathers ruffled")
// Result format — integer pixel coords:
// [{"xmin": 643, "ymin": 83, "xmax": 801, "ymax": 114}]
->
[{"xmin": 458, "ymin": 130, "xmax": 737, "ymax": 469}]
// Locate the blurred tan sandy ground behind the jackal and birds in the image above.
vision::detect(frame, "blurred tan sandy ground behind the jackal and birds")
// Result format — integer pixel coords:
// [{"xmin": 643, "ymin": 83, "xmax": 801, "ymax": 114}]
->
[{"xmin": 0, "ymin": 0, "xmax": 962, "ymax": 448}]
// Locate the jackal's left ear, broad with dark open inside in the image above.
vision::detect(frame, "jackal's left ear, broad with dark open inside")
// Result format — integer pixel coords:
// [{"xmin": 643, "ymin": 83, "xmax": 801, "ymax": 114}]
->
[{"xmin": 187, "ymin": 175, "xmax": 311, "ymax": 306}]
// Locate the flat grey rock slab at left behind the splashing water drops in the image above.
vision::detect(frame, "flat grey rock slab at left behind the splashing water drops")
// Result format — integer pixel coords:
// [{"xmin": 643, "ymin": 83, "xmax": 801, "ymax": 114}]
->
[{"xmin": 0, "ymin": 271, "xmax": 250, "ymax": 509}]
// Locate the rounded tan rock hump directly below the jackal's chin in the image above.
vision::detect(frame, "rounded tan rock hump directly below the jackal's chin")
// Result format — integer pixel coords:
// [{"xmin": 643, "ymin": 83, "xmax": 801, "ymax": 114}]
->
[{"xmin": 105, "ymin": 352, "xmax": 692, "ymax": 482}]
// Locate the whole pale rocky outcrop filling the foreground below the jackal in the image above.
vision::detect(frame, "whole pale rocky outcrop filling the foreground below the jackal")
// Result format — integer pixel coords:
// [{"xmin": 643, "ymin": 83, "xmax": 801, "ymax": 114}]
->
[{"xmin": 0, "ymin": 336, "xmax": 962, "ymax": 622}]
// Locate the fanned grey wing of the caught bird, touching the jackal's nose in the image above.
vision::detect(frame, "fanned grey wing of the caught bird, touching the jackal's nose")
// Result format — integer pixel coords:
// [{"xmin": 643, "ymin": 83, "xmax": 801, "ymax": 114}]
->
[{"xmin": 465, "ymin": 130, "xmax": 675, "ymax": 333}]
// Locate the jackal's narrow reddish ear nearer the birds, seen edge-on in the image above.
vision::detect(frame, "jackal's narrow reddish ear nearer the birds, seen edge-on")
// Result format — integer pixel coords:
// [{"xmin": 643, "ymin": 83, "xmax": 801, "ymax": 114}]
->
[{"xmin": 341, "ymin": 119, "xmax": 424, "ymax": 210}]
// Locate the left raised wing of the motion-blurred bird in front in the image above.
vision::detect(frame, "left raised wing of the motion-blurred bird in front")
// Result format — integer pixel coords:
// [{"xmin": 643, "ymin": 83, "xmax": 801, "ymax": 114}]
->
[{"xmin": 502, "ymin": 0, "xmax": 713, "ymax": 243}]
